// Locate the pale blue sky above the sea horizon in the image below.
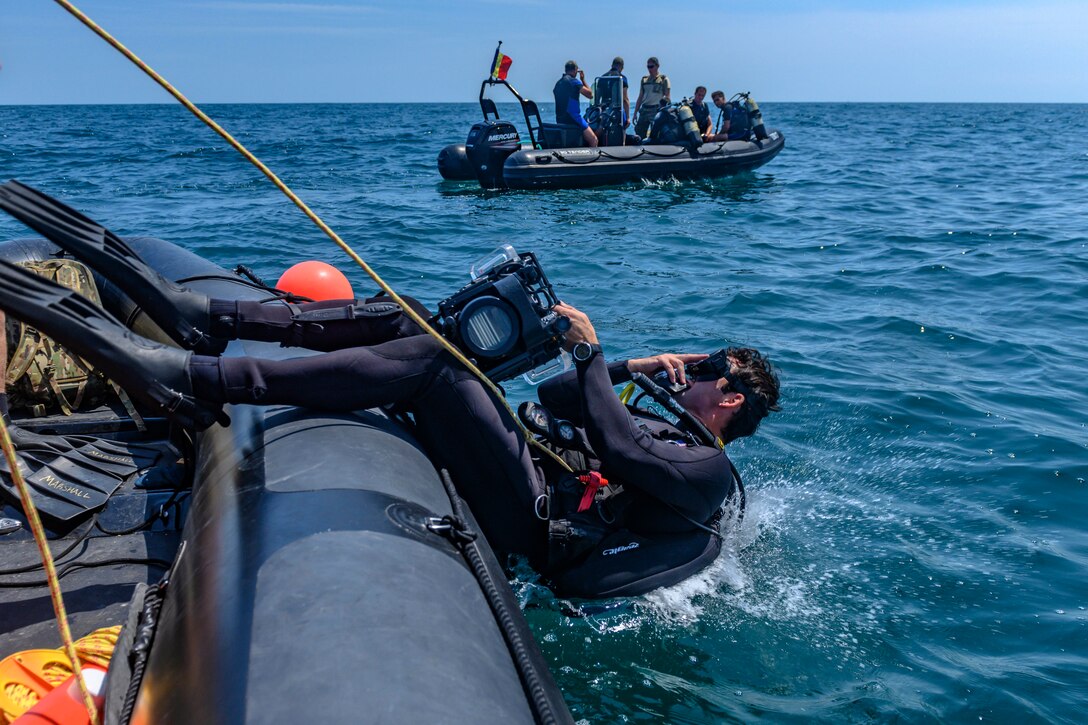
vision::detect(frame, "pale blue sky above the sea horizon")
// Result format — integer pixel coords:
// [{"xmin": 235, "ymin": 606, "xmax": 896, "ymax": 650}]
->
[{"xmin": 0, "ymin": 0, "xmax": 1088, "ymax": 105}]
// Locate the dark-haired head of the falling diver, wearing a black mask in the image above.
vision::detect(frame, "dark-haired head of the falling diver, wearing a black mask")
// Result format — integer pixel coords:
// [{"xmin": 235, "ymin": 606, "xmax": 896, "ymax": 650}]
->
[{"xmin": 677, "ymin": 347, "xmax": 780, "ymax": 443}]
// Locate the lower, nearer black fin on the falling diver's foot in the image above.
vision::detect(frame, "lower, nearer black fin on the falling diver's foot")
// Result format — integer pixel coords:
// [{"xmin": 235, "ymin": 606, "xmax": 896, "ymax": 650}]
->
[{"xmin": 0, "ymin": 260, "xmax": 230, "ymax": 429}]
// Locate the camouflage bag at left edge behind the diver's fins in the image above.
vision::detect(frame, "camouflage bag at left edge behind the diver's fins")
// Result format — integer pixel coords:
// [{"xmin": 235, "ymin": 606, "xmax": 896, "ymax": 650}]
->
[{"xmin": 7, "ymin": 259, "xmax": 115, "ymax": 417}]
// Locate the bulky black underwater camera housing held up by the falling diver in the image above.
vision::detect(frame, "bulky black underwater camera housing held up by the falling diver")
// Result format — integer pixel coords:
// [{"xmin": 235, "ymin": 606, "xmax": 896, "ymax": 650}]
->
[{"xmin": 430, "ymin": 244, "xmax": 570, "ymax": 383}]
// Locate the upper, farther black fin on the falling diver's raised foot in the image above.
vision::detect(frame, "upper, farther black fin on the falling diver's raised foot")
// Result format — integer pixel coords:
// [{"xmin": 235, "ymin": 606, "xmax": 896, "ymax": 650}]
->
[{"xmin": 0, "ymin": 181, "xmax": 220, "ymax": 354}]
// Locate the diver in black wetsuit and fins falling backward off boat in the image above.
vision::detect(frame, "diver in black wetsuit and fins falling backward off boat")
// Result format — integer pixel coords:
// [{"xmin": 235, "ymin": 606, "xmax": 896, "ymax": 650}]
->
[{"xmin": 0, "ymin": 183, "xmax": 778, "ymax": 587}]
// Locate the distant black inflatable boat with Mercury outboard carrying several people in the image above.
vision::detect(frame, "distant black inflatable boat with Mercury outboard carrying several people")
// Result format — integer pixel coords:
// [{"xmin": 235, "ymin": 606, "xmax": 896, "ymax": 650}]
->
[{"xmin": 438, "ymin": 78, "xmax": 786, "ymax": 189}]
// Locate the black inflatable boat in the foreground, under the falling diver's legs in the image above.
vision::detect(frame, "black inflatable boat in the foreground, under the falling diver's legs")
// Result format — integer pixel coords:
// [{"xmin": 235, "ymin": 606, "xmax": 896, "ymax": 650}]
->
[{"xmin": 0, "ymin": 238, "xmax": 571, "ymax": 725}]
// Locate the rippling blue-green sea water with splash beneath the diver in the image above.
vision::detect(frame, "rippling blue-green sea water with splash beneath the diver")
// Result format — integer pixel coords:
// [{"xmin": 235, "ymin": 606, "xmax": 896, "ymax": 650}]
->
[{"xmin": 0, "ymin": 103, "xmax": 1088, "ymax": 724}]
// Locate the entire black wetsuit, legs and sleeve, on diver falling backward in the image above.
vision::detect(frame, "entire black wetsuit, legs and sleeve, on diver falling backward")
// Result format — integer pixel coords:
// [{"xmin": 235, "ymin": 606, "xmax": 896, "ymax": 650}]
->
[{"xmin": 189, "ymin": 300, "xmax": 735, "ymax": 558}]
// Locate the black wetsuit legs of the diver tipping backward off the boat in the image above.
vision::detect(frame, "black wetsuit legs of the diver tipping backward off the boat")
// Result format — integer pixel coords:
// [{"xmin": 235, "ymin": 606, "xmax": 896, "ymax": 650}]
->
[{"xmin": 189, "ymin": 293, "xmax": 547, "ymax": 555}]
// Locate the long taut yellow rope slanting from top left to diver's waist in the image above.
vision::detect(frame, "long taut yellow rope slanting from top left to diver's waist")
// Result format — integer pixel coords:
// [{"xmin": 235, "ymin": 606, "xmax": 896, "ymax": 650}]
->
[{"xmin": 54, "ymin": 0, "xmax": 571, "ymax": 471}]
